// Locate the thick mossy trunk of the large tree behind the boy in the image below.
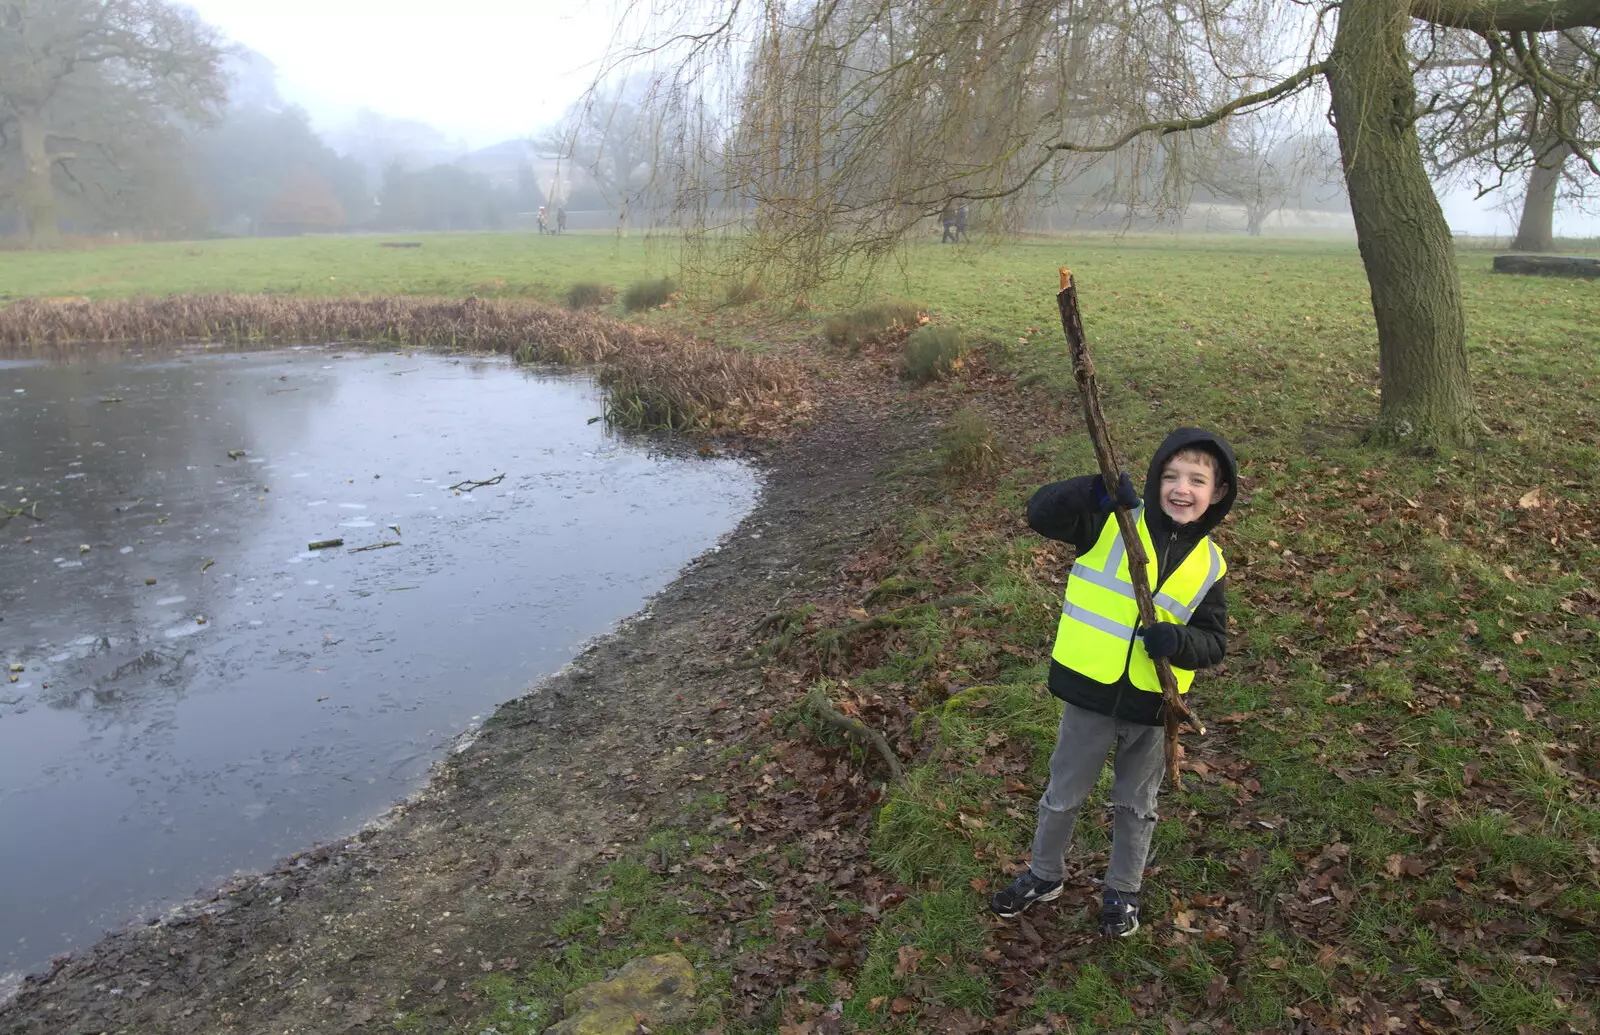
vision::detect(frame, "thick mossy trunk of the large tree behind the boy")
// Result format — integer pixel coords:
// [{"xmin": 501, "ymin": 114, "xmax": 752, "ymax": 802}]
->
[{"xmin": 1328, "ymin": 0, "xmax": 1480, "ymax": 446}]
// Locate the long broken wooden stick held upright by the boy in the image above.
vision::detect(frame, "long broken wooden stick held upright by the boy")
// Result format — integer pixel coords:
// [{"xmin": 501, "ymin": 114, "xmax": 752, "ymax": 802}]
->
[{"xmin": 1056, "ymin": 266, "xmax": 1205, "ymax": 787}]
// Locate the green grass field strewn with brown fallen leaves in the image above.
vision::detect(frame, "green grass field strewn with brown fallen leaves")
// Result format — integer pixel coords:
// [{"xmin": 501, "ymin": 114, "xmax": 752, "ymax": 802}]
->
[{"xmin": 0, "ymin": 237, "xmax": 1600, "ymax": 1035}]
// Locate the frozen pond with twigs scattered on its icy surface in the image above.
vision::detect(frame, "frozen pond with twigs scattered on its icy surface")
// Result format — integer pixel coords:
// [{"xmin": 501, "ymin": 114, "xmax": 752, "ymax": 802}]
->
[{"xmin": 0, "ymin": 347, "xmax": 758, "ymax": 976}]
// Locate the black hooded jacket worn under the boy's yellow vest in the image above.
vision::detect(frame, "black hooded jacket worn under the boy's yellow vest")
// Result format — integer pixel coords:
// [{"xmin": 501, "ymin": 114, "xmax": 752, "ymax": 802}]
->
[{"xmin": 1027, "ymin": 427, "xmax": 1238, "ymax": 726}]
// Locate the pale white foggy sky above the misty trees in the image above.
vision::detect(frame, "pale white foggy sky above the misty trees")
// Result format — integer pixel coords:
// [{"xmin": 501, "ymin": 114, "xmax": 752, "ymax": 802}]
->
[{"xmin": 189, "ymin": 0, "xmax": 1600, "ymax": 237}]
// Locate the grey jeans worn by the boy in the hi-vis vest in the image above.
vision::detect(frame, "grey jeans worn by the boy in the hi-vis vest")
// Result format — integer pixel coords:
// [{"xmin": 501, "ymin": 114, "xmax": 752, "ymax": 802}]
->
[{"xmin": 1029, "ymin": 704, "xmax": 1166, "ymax": 891}]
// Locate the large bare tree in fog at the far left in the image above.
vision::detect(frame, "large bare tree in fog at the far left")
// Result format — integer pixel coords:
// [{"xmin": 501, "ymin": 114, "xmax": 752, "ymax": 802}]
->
[{"xmin": 0, "ymin": 0, "xmax": 222, "ymax": 246}]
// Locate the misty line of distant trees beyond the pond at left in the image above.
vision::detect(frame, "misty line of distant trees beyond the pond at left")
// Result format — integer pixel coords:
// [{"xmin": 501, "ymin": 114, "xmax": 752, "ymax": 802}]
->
[{"xmin": 0, "ymin": 0, "xmax": 546, "ymax": 248}]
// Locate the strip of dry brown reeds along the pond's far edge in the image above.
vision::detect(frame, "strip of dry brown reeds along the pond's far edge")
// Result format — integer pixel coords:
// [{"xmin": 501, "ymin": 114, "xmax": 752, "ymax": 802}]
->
[{"xmin": 0, "ymin": 294, "xmax": 808, "ymax": 432}]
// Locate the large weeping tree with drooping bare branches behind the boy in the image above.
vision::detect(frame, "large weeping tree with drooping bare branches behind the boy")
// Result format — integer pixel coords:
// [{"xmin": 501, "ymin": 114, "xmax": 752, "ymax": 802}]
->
[{"xmin": 617, "ymin": 0, "xmax": 1600, "ymax": 446}]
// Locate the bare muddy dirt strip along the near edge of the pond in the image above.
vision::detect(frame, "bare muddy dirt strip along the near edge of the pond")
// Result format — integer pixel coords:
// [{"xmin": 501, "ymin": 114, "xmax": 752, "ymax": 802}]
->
[{"xmin": 0, "ymin": 394, "xmax": 931, "ymax": 1035}]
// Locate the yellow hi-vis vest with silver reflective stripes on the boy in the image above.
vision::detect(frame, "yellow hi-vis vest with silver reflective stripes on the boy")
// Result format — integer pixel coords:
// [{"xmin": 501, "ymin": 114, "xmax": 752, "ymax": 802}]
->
[{"xmin": 1050, "ymin": 507, "xmax": 1227, "ymax": 694}]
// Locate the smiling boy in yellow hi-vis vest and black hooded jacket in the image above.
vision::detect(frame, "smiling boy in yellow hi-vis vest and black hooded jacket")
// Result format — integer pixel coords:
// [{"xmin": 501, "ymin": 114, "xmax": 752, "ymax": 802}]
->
[{"xmin": 989, "ymin": 427, "xmax": 1238, "ymax": 937}]
